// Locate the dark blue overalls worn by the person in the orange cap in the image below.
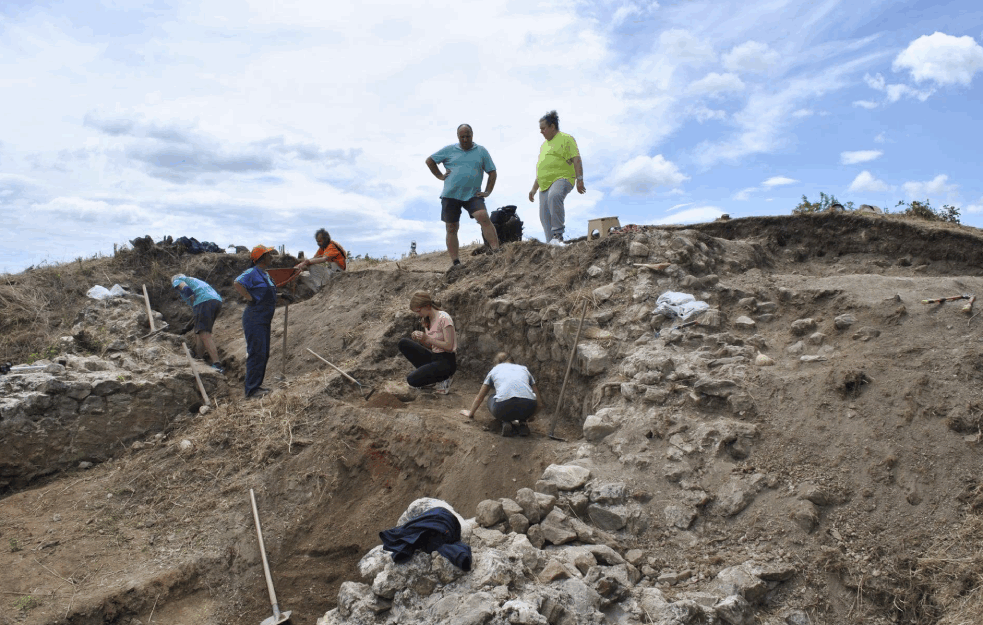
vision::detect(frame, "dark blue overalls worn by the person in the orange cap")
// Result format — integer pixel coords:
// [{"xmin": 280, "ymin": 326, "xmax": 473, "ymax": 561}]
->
[{"xmin": 236, "ymin": 267, "xmax": 276, "ymax": 397}]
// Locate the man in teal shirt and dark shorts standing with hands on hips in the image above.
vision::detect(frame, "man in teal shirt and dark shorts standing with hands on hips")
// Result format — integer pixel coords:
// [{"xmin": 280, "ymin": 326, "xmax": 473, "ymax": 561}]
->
[{"xmin": 427, "ymin": 124, "xmax": 498, "ymax": 268}]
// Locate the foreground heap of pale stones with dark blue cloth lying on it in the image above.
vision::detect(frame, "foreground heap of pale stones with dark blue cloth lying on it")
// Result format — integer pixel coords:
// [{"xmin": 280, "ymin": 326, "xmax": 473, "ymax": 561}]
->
[{"xmin": 318, "ymin": 465, "xmax": 795, "ymax": 625}]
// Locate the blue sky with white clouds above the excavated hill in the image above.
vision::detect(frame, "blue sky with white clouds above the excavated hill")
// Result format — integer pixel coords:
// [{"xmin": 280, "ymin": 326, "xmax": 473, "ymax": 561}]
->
[{"xmin": 0, "ymin": 0, "xmax": 983, "ymax": 272}]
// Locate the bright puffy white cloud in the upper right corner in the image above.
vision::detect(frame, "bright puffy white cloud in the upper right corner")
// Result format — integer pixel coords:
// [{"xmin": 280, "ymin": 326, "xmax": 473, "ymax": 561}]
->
[{"xmin": 891, "ymin": 32, "xmax": 983, "ymax": 87}]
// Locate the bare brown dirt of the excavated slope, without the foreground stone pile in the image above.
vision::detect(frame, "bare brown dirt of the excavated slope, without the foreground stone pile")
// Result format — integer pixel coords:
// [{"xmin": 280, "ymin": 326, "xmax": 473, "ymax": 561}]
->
[{"xmin": 0, "ymin": 215, "xmax": 983, "ymax": 624}]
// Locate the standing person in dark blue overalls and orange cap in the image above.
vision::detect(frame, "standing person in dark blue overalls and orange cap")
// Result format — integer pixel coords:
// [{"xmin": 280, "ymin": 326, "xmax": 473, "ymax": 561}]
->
[{"xmin": 234, "ymin": 245, "xmax": 290, "ymax": 398}]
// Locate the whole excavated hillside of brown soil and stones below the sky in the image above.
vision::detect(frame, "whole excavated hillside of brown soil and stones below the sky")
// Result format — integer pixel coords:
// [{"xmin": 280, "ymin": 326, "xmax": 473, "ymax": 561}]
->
[{"xmin": 0, "ymin": 214, "xmax": 983, "ymax": 625}]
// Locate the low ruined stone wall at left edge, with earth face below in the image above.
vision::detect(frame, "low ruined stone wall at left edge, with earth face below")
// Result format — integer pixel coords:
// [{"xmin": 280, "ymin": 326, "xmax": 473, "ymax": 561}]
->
[{"xmin": 0, "ymin": 297, "xmax": 220, "ymax": 488}]
